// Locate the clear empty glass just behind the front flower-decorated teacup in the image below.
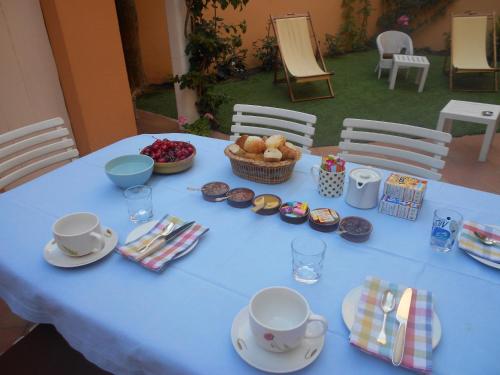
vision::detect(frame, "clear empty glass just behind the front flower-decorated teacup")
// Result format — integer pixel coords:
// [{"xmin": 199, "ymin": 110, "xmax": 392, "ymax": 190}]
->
[{"xmin": 292, "ymin": 235, "xmax": 326, "ymax": 284}]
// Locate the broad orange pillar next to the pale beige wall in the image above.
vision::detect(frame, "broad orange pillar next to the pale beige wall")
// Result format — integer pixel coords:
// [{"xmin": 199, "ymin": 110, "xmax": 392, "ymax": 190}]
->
[{"xmin": 40, "ymin": 0, "xmax": 137, "ymax": 154}]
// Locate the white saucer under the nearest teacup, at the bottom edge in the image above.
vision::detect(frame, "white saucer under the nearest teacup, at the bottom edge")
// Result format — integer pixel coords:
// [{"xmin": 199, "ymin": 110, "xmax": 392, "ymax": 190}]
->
[{"xmin": 231, "ymin": 307, "xmax": 325, "ymax": 374}]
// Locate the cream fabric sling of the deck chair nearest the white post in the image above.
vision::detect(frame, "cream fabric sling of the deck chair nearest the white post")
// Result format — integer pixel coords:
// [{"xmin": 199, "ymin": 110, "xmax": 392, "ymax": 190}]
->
[{"xmin": 271, "ymin": 14, "xmax": 326, "ymax": 77}]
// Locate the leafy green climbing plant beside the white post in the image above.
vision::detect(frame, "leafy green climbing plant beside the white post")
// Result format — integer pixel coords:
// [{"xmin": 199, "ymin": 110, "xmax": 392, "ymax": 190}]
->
[{"xmin": 174, "ymin": 0, "xmax": 249, "ymax": 125}]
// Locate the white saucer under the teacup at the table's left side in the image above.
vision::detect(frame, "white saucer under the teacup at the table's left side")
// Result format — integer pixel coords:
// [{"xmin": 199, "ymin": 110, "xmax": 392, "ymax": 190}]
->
[{"xmin": 43, "ymin": 228, "xmax": 118, "ymax": 268}]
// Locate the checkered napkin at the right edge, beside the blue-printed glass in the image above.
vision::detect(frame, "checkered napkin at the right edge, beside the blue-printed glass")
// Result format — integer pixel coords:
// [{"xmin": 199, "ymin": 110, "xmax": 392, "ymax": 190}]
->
[{"xmin": 458, "ymin": 221, "xmax": 500, "ymax": 263}]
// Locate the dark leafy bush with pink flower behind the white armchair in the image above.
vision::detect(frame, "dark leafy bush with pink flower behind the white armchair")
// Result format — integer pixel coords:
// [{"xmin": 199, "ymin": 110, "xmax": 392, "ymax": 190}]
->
[{"xmin": 377, "ymin": 0, "xmax": 455, "ymax": 33}]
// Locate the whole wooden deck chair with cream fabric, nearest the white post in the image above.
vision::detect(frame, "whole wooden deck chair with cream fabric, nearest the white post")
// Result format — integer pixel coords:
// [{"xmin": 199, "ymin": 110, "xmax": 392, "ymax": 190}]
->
[{"xmin": 271, "ymin": 13, "xmax": 335, "ymax": 102}]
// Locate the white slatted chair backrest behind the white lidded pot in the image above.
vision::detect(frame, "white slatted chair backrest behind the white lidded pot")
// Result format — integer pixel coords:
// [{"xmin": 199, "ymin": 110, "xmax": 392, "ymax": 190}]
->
[{"xmin": 339, "ymin": 118, "xmax": 451, "ymax": 180}]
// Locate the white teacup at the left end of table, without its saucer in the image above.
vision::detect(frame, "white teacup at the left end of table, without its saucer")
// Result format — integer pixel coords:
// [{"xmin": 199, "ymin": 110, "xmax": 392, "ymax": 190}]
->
[{"xmin": 52, "ymin": 212, "xmax": 104, "ymax": 256}]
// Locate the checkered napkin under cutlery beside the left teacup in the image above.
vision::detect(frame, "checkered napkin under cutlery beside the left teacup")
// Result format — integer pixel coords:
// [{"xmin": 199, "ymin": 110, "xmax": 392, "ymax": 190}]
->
[{"xmin": 117, "ymin": 215, "xmax": 208, "ymax": 272}]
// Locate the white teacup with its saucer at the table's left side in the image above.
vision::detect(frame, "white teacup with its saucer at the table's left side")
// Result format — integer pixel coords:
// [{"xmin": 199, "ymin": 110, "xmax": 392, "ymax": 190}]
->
[{"xmin": 44, "ymin": 212, "xmax": 118, "ymax": 267}]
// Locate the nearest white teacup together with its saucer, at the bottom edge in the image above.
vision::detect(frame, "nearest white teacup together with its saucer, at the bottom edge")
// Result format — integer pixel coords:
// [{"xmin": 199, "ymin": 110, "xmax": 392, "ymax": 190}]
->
[{"xmin": 231, "ymin": 287, "xmax": 327, "ymax": 373}]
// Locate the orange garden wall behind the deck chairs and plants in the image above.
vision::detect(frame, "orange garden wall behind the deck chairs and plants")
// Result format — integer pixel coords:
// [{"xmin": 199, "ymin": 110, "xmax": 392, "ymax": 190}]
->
[{"xmin": 136, "ymin": 0, "xmax": 500, "ymax": 83}]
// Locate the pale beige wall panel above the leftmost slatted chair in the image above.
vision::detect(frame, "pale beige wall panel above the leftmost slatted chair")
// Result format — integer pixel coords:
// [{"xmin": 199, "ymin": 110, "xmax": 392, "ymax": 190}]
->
[{"xmin": 0, "ymin": 0, "xmax": 71, "ymax": 138}]
